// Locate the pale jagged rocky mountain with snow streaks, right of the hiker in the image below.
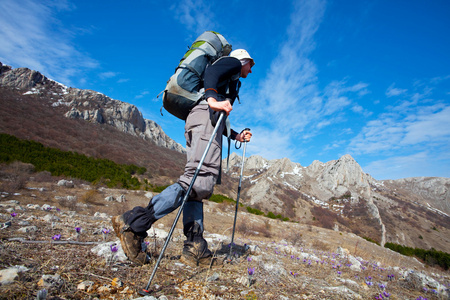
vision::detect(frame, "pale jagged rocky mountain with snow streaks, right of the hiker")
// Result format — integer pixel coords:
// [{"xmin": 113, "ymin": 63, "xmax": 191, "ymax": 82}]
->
[{"xmin": 228, "ymin": 154, "xmax": 450, "ymax": 251}]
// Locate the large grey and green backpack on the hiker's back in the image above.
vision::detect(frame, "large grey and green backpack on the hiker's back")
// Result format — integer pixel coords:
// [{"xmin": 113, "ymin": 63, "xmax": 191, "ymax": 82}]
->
[{"xmin": 161, "ymin": 31, "xmax": 231, "ymax": 120}]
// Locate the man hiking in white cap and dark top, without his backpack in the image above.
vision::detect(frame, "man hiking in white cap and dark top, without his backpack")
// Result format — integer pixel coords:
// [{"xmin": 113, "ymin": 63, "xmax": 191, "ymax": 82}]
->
[{"xmin": 112, "ymin": 49, "xmax": 255, "ymax": 264}]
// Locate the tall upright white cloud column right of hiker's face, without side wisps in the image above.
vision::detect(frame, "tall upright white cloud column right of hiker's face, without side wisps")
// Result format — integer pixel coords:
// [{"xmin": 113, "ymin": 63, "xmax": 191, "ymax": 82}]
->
[{"xmin": 256, "ymin": 1, "xmax": 325, "ymax": 132}]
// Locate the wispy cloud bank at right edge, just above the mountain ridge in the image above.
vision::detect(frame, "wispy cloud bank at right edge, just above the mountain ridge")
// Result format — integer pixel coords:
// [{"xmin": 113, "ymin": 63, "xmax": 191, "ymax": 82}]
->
[{"xmin": 349, "ymin": 84, "xmax": 450, "ymax": 155}]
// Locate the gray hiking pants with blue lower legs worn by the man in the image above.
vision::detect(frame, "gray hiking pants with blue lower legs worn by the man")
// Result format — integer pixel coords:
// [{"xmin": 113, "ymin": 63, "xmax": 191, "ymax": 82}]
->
[{"xmin": 124, "ymin": 104, "xmax": 225, "ymax": 236}]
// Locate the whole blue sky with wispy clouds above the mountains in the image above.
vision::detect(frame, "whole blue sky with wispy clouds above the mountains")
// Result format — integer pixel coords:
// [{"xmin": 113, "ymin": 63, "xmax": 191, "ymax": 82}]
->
[{"xmin": 0, "ymin": 0, "xmax": 450, "ymax": 180}]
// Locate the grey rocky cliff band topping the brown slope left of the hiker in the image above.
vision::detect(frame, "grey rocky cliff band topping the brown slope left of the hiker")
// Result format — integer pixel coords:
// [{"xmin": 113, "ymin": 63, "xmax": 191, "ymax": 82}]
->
[{"xmin": 0, "ymin": 62, "xmax": 185, "ymax": 153}]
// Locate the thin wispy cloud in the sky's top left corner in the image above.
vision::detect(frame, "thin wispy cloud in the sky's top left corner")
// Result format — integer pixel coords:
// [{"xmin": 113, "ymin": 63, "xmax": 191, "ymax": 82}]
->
[{"xmin": 0, "ymin": 0, "xmax": 98, "ymax": 84}]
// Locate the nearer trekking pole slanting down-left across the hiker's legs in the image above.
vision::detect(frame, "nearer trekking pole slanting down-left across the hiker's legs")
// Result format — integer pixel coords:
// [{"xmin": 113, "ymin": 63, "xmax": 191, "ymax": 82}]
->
[{"xmin": 139, "ymin": 111, "xmax": 225, "ymax": 296}]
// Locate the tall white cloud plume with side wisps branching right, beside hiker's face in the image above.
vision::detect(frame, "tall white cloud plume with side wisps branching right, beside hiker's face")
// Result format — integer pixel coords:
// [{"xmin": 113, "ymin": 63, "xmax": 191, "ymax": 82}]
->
[{"xmin": 252, "ymin": 1, "xmax": 370, "ymax": 148}]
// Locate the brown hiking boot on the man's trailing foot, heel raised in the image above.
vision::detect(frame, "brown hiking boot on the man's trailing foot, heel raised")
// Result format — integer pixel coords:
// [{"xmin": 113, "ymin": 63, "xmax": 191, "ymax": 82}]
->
[{"xmin": 111, "ymin": 216, "xmax": 150, "ymax": 265}]
